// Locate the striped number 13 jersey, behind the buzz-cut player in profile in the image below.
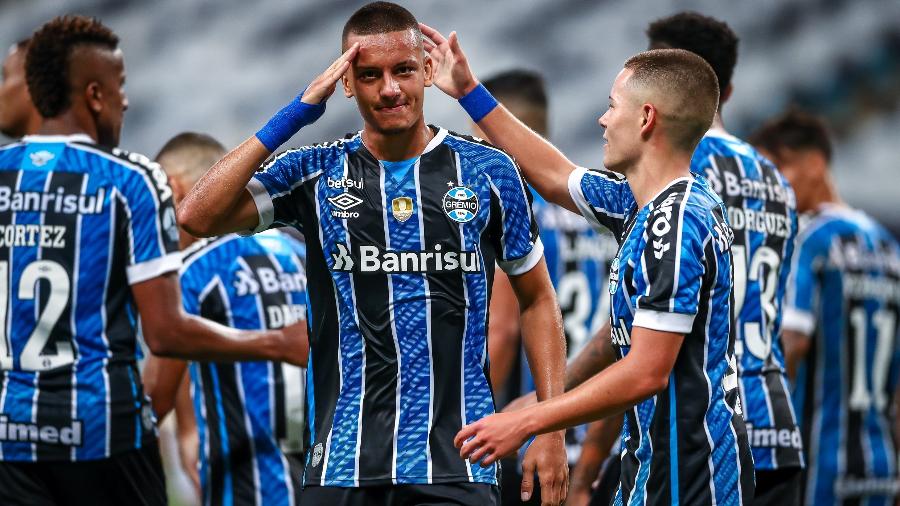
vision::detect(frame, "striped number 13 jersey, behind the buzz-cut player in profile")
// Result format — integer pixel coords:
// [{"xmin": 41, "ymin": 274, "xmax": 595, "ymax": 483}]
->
[{"xmin": 691, "ymin": 130, "xmax": 803, "ymax": 469}]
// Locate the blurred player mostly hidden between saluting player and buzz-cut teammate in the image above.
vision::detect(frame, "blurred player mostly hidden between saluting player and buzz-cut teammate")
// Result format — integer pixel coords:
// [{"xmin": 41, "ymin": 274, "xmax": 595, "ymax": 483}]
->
[{"xmin": 475, "ymin": 69, "xmax": 618, "ymax": 502}]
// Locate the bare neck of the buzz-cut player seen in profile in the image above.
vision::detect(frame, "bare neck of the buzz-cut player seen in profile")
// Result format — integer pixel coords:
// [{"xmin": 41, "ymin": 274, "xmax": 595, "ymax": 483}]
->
[{"xmin": 625, "ymin": 150, "xmax": 691, "ymax": 208}]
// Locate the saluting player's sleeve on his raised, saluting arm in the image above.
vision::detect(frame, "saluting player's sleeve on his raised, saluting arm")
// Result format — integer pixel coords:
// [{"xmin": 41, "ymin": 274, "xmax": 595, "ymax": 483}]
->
[{"xmin": 241, "ymin": 146, "xmax": 330, "ymax": 235}]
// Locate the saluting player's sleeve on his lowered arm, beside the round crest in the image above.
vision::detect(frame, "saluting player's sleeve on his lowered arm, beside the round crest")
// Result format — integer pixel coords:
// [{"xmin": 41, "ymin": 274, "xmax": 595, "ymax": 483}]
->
[{"xmin": 490, "ymin": 154, "xmax": 544, "ymax": 276}]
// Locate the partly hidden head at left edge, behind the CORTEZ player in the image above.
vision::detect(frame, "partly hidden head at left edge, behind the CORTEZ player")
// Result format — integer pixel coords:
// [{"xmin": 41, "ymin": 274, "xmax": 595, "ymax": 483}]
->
[{"xmin": 0, "ymin": 39, "xmax": 41, "ymax": 139}]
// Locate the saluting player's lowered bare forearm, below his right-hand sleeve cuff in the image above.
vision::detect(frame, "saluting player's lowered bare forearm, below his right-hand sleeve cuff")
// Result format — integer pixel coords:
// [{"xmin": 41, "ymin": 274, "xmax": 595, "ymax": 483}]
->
[{"xmin": 521, "ymin": 292, "xmax": 566, "ymax": 400}]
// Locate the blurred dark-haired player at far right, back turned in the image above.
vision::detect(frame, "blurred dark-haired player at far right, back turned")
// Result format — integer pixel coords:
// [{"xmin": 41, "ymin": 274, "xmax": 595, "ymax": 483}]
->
[{"xmin": 751, "ymin": 111, "xmax": 900, "ymax": 506}]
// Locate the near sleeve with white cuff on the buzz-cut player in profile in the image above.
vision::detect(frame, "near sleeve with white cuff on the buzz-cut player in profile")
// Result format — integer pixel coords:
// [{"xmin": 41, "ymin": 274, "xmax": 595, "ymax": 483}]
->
[{"xmin": 632, "ymin": 193, "xmax": 712, "ymax": 334}]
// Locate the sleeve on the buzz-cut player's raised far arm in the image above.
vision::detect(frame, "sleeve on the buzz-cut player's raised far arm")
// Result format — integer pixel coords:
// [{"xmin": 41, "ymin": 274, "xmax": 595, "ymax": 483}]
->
[{"xmin": 569, "ymin": 167, "xmax": 635, "ymax": 238}]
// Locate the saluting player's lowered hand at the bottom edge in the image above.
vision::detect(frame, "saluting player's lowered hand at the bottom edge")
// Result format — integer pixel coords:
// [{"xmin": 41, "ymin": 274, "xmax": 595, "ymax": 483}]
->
[{"xmin": 522, "ymin": 432, "xmax": 569, "ymax": 506}]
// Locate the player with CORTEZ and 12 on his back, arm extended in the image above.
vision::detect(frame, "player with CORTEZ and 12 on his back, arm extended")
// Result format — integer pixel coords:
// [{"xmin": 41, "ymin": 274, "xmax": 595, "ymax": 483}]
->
[{"xmin": 0, "ymin": 16, "xmax": 303, "ymax": 505}]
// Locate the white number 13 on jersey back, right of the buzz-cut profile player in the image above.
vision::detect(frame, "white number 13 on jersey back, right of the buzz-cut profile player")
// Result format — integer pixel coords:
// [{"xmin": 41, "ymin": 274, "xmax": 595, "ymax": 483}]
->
[{"xmin": 731, "ymin": 244, "xmax": 781, "ymax": 360}]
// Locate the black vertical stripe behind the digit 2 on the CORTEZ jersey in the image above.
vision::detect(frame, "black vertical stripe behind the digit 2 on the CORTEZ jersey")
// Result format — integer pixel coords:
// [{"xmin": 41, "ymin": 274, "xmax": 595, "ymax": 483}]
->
[{"xmin": 35, "ymin": 172, "xmax": 80, "ymax": 460}]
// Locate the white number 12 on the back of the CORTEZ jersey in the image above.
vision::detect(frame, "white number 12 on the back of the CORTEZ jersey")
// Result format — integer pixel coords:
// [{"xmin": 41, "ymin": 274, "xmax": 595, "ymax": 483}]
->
[{"xmin": 0, "ymin": 260, "xmax": 75, "ymax": 371}]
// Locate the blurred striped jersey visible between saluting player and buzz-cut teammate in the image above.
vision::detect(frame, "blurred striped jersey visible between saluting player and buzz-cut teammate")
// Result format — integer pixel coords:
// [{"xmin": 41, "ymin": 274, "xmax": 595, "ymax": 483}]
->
[{"xmin": 520, "ymin": 192, "xmax": 619, "ymax": 465}]
